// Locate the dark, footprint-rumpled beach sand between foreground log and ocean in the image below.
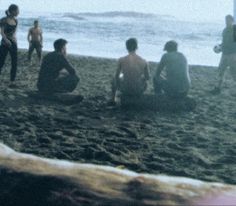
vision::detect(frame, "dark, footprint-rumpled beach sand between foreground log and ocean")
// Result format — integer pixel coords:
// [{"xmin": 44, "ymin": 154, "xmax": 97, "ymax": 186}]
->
[{"xmin": 0, "ymin": 51, "xmax": 236, "ymax": 184}]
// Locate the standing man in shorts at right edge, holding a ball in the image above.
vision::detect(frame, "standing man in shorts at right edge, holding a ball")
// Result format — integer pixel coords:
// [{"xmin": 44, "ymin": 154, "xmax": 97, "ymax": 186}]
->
[{"xmin": 211, "ymin": 15, "xmax": 236, "ymax": 94}]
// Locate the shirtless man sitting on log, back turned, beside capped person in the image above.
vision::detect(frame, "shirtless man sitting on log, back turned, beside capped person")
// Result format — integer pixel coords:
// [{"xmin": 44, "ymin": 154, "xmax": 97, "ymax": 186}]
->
[{"xmin": 111, "ymin": 38, "xmax": 150, "ymax": 104}]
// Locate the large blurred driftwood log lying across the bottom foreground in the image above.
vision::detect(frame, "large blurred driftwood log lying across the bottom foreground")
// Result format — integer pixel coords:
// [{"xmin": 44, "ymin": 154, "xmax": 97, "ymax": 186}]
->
[{"xmin": 0, "ymin": 144, "xmax": 236, "ymax": 206}]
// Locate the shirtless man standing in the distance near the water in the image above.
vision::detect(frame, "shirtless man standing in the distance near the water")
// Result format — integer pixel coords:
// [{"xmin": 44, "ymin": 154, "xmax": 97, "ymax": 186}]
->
[{"xmin": 27, "ymin": 20, "xmax": 43, "ymax": 62}]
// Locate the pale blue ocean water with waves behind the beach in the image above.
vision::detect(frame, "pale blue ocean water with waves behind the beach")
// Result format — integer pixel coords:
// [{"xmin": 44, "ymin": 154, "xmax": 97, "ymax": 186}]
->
[{"xmin": 0, "ymin": 8, "xmax": 230, "ymax": 66}]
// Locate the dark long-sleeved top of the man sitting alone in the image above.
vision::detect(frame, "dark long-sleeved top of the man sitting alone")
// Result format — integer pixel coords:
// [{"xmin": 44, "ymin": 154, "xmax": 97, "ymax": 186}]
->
[{"xmin": 38, "ymin": 51, "xmax": 75, "ymax": 87}]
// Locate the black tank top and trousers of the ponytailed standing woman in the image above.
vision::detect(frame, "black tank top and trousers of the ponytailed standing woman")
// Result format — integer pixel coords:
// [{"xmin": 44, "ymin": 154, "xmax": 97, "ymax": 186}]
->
[{"xmin": 0, "ymin": 17, "xmax": 18, "ymax": 81}]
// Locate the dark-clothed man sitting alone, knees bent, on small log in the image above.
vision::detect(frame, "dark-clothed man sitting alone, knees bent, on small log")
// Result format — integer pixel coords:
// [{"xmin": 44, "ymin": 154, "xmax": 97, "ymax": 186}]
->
[{"xmin": 37, "ymin": 39, "xmax": 79, "ymax": 95}]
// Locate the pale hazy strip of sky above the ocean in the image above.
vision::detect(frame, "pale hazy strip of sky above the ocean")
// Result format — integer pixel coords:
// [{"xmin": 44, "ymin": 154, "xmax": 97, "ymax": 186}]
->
[{"xmin": 0, "ymin": 0, "xmax": 233, "ymax": 20}]
